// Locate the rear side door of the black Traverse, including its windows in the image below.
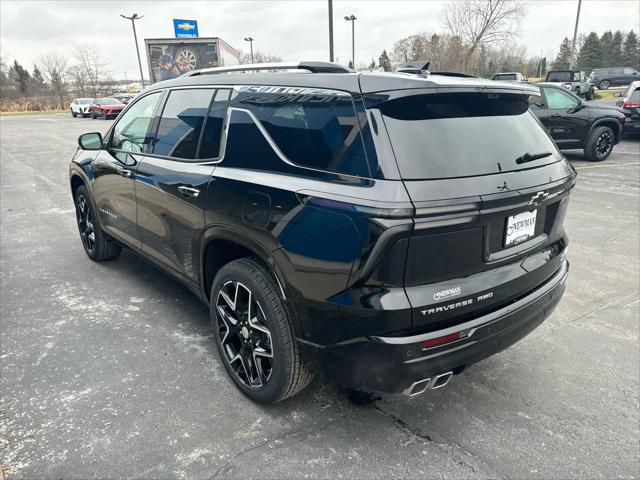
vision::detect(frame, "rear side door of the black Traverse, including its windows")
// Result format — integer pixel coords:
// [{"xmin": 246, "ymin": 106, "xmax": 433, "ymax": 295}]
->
[{"xmin": 136, "ymin": 88, "xmax": 230, "ymax": 285}]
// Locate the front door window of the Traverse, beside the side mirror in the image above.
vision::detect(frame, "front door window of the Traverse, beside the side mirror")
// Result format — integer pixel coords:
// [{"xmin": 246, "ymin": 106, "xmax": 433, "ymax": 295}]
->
[{"xmin": 111, "ymin": 92, "xmax": 162, "ymax": 153}]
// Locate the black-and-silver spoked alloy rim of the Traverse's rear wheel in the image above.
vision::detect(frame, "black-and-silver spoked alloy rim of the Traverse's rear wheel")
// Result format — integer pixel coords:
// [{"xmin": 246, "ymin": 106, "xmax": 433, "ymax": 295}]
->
[{"xmin": 216, "ymin": 281, "xmax": 273, "ymax": 389}]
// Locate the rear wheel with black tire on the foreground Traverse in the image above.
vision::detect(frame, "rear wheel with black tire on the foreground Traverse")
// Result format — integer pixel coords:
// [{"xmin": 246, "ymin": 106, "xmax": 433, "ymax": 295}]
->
[{"xmin": 210, "ymin": 258, "xmax": 313, "ymax": 403}]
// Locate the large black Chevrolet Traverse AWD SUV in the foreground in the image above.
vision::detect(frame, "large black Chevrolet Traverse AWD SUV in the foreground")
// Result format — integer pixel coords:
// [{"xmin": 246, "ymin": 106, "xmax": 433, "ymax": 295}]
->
[{"xmin": 70, "ymin": 63, "xmax": 576, "ymax": 402}]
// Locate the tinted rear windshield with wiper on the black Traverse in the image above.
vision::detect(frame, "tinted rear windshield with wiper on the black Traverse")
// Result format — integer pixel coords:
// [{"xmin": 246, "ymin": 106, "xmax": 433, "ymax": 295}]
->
[{"xmin": 379, "ymin": 93, "xmax": 561, "ymax": 180}]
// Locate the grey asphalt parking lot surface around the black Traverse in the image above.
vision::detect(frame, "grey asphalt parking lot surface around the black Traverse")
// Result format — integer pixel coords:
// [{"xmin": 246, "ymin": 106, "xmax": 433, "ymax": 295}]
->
[{"xmin": 0, "ymin": 114, "xmax": 640, "ymax": 479}]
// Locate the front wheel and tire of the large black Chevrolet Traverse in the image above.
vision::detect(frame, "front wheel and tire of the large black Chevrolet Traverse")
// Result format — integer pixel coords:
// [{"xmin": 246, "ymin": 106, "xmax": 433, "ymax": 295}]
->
[{"xmin": 74, "ymin": 185, "xmax": 122, "ymax": 262}]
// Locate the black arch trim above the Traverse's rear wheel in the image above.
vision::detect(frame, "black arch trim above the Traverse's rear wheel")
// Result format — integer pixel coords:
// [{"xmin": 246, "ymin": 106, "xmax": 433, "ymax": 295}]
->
[{"xmin": 200, "ymin": 225, "xmax": 291, "ymax": 301}]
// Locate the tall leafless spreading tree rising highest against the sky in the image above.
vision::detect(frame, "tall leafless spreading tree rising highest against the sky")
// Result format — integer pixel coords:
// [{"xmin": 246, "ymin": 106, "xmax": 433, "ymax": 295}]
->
[{"xmin": 442, "ymin": 0, "xmax": 525, "ymax": 68}]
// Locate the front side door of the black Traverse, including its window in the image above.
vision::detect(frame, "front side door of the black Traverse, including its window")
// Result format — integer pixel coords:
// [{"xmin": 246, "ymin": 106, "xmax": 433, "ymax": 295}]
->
[{"xmin": 92, "ymin": 92, "xmax": 162, "ymax": 250}]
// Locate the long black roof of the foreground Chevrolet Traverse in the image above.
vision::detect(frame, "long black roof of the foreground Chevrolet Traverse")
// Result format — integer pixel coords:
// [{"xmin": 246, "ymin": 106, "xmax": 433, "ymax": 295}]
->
[{"xmin": 145, "ymin": 72, "xmax": 535, "ymax": 94}]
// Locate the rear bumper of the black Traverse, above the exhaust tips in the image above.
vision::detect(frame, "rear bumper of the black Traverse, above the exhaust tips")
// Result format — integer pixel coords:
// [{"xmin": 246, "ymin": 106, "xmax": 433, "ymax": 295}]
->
[{"xmin": 300, "ymin": 261, "xmax": 569, "ymax": 393}]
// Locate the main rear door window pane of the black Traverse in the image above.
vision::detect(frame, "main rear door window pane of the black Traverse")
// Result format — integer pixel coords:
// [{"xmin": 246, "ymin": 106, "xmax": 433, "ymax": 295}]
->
[{"xmin": 152, "ymin": 89, "xmax": 215, "ymax": 160}]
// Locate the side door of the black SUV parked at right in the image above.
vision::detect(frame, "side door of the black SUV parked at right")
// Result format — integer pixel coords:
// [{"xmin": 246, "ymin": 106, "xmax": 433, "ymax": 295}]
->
[{"xmin": 536, "ymin": 86, "xmax": 589, "ymax": 148}]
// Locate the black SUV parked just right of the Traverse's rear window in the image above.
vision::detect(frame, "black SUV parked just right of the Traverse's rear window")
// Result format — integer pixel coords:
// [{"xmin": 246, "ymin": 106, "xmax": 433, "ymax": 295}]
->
[{"xmin": 529, "ymin": 83, "xmax": 625, "ymax": 162}]
